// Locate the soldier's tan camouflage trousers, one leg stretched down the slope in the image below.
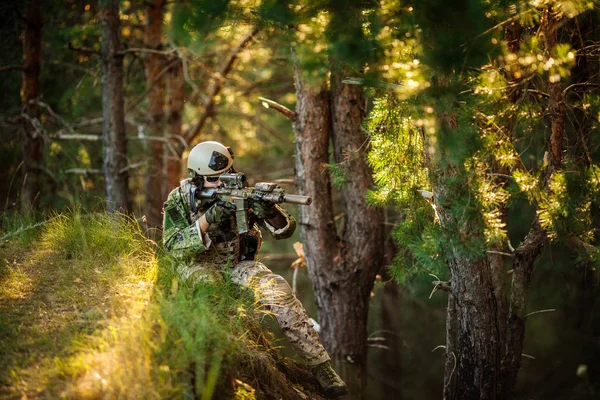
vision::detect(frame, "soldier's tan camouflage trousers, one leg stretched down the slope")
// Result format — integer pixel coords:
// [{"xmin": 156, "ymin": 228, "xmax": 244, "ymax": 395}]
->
[{"xmin": 178, "ymin": 261, "xmax": 329, "ymax": 367}]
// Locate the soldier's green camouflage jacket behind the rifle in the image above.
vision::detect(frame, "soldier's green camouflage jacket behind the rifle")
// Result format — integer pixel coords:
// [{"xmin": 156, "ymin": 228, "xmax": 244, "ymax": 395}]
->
[{"xmin": 163, "ymin": 179, "xmax": 296, "ymax": 264}]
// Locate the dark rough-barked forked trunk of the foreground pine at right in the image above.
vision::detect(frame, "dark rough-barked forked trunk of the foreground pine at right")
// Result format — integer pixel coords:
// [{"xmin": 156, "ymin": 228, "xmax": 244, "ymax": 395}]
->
[{"xmin": 444, "ymin": 8, "xmax": 567, "ymax": 399}]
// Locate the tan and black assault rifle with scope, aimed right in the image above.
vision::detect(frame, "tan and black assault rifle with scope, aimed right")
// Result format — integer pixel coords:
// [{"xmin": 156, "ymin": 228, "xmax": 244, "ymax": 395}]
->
[{"xmin": 195, "ymin": 172, "xmax": 312, "ymax": 233}]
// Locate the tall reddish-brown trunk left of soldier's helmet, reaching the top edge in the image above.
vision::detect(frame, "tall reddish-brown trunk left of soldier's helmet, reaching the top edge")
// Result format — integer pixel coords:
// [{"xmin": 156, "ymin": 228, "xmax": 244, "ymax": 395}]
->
[{"xmin": 144, "ymin": 0, "xmax": 167, "ymax": 228}]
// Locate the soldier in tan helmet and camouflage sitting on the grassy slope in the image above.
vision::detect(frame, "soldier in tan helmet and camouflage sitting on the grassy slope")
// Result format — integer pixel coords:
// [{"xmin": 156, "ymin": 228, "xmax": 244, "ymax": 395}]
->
[{"xmin": 163, "ymin": 142, "xmax": 348, "ymax": 398}]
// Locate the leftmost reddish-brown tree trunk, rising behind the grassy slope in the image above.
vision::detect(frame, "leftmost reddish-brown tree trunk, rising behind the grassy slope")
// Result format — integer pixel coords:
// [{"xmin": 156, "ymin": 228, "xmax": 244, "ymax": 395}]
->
[{"xmin": 21, "ymin": 0, "xmax": 43, "ymax": 210}]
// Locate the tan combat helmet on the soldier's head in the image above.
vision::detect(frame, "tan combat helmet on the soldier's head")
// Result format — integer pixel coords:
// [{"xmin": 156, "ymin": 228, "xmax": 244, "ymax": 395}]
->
[{"xmin": 188, "ymin": 142, "xmax": 233, "ymax": 177}]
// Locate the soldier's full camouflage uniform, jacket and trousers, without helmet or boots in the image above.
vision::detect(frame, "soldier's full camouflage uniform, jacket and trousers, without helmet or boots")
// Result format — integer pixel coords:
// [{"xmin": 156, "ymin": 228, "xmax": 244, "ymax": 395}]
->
[{"xmin": 163, "ymin": 179, "xmax": 329, "ymax": 366}]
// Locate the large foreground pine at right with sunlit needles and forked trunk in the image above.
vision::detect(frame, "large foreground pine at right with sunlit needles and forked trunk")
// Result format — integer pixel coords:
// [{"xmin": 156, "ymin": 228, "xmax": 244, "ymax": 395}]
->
[{"xmin": 369, "ymin": 1, "xmax": 597, "ymax": 399}]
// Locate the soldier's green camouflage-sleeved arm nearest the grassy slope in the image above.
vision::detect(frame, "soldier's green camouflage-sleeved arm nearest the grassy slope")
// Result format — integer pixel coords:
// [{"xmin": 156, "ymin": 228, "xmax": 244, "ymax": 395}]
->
[{"xmin": 163, "ymin": 189, "xmax": 210, "ymax": 258}]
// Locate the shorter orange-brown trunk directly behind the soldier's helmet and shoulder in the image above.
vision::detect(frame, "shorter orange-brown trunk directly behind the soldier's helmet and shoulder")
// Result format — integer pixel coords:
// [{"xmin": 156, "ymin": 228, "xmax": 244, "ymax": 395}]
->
[{"xmin": 165, "ymin": 60, "xmax": 186, "ymax": 190}]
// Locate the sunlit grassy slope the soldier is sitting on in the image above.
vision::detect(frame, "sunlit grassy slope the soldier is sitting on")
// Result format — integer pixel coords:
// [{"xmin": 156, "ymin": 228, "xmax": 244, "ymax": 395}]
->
[{"xmin": 0, "ymin": 212, "xmax": 320, "ymax": 399}]
